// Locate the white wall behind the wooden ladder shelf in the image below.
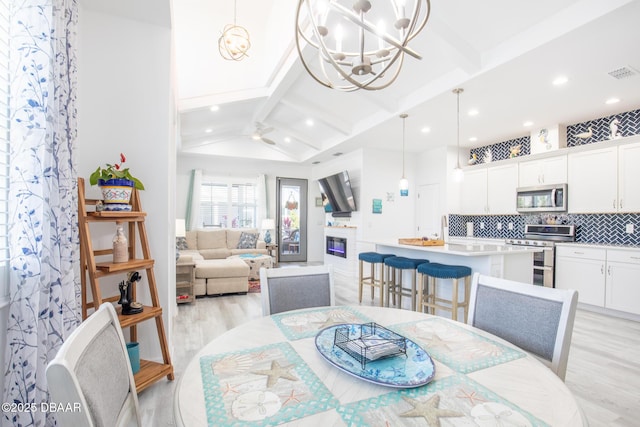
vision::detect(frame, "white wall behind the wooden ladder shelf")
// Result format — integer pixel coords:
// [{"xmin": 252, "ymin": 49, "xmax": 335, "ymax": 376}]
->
[{"xmin": 77, "ymin": 7, "xmax": 175, "ymax": 360}]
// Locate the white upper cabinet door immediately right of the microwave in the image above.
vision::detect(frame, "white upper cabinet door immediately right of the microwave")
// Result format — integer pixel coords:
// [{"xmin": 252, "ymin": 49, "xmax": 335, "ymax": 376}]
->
[{"xmin": 567, "ymin": 147, "xmax": 618, "ymax": 213}]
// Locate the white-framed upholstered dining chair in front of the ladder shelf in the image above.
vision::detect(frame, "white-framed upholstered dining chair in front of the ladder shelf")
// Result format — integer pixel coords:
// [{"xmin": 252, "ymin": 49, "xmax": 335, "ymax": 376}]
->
[{"xmin": 46, "ymin": 303, "xmax": 142, "ymax": 427}]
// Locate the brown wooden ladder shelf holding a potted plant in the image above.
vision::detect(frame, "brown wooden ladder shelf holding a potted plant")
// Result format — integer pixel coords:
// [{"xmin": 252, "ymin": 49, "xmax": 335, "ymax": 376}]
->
[{"xmin": 78, "ymin": 178, "xmax": 174, "ymax": 392}]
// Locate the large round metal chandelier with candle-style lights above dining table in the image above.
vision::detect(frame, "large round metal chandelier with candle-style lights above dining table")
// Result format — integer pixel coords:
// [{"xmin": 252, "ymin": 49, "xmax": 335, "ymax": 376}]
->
[{"xmin": 296, "ymin": 0, "xmax": 431, "ymax": 92}]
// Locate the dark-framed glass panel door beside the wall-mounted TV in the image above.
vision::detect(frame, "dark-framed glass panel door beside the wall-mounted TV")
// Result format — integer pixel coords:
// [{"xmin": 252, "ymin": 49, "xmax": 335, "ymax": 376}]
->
[{"xmin": 276, "ymin": 177, "xmax": 307, "ymax": 262}]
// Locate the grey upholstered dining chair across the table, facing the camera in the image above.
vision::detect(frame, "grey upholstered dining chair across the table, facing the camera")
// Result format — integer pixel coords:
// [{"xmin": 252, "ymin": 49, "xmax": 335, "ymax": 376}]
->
[{"xmin": 260, "ymin": 265, "xmax": 334, "ymax": 316}]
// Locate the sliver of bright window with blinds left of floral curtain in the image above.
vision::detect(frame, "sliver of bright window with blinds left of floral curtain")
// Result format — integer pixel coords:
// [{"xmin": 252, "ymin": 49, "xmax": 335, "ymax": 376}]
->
[{"xmin": 0, "ymin": 0, "xmax": 9, "ymax": 300}]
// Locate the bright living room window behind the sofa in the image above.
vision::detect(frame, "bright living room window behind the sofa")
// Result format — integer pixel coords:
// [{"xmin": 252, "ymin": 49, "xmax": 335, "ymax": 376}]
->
[{"xmin": 200, "ymin": 181, "xmax": 257, "ymax": 228}]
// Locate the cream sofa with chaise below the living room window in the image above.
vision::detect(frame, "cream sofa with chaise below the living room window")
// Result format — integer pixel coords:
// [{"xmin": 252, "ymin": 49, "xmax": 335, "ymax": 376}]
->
[{"xmin": 178, "ymin": 228, "xmax": 268, "ymax": 296}]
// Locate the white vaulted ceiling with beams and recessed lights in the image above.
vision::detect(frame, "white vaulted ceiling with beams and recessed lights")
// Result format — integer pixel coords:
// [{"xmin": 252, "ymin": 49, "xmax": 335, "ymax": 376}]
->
[{"xmin": 92, "ymin": 0, "xmax": 640, "ymax": 163}]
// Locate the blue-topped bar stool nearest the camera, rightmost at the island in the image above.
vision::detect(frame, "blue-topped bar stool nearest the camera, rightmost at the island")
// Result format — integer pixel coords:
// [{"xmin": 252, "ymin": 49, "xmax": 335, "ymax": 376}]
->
[{"xmin": 417, "ymin": 262, "xmax": 471, "ymax": 323}]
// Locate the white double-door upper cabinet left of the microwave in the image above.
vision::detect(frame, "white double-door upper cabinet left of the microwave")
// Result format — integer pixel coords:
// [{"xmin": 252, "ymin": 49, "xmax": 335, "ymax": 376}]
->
[{"xmin": 460, "ymin": 163, "xmax": 518, "ymax": 215}]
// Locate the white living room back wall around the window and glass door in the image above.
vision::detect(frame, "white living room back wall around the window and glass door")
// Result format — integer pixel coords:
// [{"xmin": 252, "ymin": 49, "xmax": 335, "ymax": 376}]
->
[{"xmin": 175, "ymin": 154, "xmax": 324, "ymax": 262}]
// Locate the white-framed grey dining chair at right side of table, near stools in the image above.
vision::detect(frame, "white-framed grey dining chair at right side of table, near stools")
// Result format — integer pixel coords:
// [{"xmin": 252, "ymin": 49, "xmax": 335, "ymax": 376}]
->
[{"xmin": 467, "ymin": 273, "xmax": 578, "ymax": 381}]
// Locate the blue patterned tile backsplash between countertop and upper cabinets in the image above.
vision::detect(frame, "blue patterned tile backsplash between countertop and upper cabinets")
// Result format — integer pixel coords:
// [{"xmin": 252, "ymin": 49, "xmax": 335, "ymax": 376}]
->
[{"xmin": 449, "ymin": 213, "xmax": 640, "ymax": 246}]
